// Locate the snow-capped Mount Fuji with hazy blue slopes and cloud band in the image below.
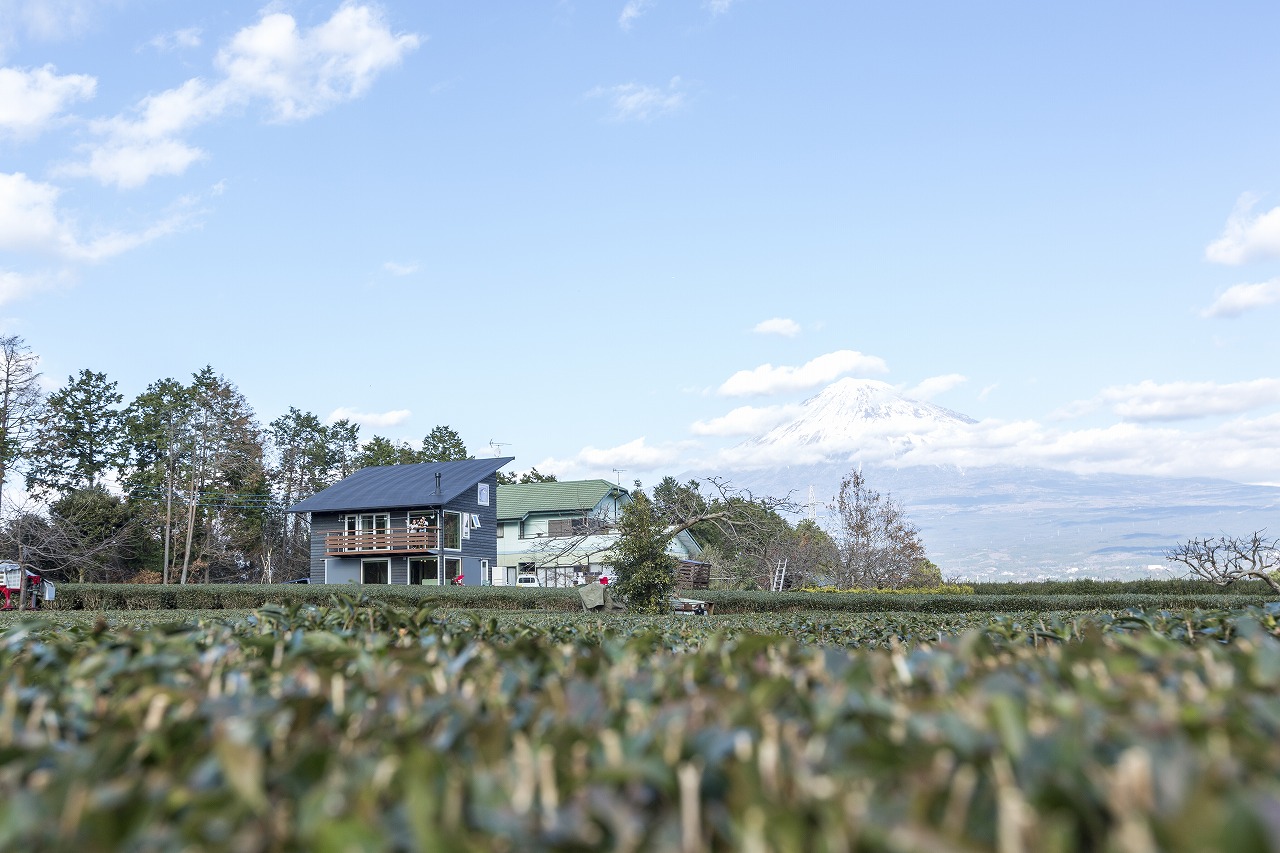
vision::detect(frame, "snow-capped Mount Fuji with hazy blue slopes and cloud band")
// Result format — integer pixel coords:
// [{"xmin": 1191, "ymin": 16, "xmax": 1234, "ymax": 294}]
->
[{"xmin": 701, "ymin": 379, "xmax": 1280, "ymax": 580}]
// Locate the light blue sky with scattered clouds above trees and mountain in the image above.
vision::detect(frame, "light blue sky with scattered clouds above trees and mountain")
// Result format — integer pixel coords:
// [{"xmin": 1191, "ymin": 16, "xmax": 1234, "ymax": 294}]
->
[{"xmin": 0, "ymin": 0, "xmax": 1280, "ymax": 483}]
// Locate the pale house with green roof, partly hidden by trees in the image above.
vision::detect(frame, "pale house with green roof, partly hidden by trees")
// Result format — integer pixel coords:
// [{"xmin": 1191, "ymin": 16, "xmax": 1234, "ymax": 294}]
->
[{"xmin": 493, "ymin": 480, "xmax": 701, "ymax": 587}]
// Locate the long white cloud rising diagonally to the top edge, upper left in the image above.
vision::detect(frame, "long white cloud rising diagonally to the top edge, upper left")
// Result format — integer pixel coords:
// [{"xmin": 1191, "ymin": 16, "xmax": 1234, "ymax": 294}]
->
[{"xmin": 58, "ymin": 3, "xmax": 420, "ymax": 188}]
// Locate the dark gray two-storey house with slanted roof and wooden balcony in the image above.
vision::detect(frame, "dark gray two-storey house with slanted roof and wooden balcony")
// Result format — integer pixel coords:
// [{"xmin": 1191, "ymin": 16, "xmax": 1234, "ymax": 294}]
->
[{"xmin": 288, "ymin": 456, "xmax": 513, "ymax": 585}]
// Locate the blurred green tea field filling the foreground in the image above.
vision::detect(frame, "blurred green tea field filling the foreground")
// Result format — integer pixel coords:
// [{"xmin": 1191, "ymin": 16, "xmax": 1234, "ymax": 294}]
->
[{"xmin": 0, "ymin": 597, "xmax": 1280, "ymax": 853}]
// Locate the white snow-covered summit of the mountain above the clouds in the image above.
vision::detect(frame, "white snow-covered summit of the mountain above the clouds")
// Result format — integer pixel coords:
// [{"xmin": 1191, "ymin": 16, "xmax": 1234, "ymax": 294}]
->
[{"xmin": 741, "ymin": 378, "xmax": 977, "ymax": 451}]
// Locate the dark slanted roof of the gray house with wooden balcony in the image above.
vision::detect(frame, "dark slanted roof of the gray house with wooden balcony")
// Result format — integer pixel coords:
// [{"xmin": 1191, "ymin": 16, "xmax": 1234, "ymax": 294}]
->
[{"xmin": 288, "ymin": 456, "xmax": 515, "ymax": 512}]
